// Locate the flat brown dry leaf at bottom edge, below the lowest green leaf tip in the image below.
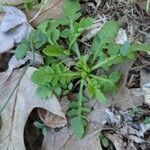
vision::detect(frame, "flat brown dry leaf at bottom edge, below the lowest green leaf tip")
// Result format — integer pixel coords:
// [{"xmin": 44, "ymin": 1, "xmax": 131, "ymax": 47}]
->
[{"xmin": 42, "ymin": 128, "xmax": 102, "ymax": 150}]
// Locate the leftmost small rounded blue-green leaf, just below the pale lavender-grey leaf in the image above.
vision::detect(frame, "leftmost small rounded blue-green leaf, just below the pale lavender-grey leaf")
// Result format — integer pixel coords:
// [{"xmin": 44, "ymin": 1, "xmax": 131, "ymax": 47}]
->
[{"xmin": 15, "ymin": 43, "xmax": 29, "ymax": 60}]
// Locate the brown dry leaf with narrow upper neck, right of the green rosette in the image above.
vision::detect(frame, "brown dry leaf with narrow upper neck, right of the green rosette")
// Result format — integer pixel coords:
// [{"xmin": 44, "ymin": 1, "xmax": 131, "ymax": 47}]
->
[{"xmin": 110, "ymin": 61, "xmax": 144, "ymax": 110}]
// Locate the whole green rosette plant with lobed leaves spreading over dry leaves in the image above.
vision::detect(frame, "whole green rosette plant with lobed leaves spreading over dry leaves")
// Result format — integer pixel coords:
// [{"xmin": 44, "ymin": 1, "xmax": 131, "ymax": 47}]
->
[{"xmin": 16, "ymin": 0, "xmax": 150, "ymax": 138}]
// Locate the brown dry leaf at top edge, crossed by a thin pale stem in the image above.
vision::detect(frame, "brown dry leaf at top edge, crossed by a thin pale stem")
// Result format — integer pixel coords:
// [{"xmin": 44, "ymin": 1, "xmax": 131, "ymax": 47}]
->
[{"xmin": 26, "ymin": 0, "xmax": 64, "ymax": 26}]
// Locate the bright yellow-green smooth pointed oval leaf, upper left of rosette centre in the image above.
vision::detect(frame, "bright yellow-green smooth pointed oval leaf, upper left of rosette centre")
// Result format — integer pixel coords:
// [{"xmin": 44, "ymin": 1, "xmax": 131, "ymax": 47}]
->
[{"xmin": 43, "ymin": 45, "xmax": 69, "ymax": 57}]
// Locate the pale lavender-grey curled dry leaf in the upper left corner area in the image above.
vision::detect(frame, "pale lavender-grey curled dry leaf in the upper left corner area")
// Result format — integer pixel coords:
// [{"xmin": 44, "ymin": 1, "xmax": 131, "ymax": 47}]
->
[{"xmin": 0, "ymin": 6, "xmax": 32, "ymax": 53}]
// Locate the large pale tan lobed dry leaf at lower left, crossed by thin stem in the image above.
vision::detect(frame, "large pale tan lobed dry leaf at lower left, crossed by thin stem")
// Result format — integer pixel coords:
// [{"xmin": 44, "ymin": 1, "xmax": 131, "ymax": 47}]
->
[{"xmin": 0, "ymin": 67, "xmax": 66, "ymax": 150}]
